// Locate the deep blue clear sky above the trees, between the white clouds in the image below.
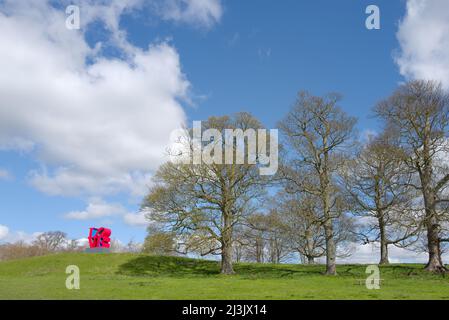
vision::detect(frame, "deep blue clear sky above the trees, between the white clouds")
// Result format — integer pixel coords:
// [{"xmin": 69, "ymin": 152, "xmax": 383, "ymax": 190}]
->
[{"xmin": 123, "ymin": 0, "xmax": 405, "ymax": 128}]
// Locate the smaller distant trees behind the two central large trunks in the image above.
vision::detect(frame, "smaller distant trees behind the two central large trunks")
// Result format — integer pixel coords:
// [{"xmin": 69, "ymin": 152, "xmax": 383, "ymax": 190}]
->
[{"xmin": 229, "ymin": 191, "xmax": 357, "ymax": 264}]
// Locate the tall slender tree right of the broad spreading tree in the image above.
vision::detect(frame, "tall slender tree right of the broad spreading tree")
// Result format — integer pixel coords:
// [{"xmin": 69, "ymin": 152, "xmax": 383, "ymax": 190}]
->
[{"xmin": 279, "ymin": 91, "xmax": 356, "ymax": 275}]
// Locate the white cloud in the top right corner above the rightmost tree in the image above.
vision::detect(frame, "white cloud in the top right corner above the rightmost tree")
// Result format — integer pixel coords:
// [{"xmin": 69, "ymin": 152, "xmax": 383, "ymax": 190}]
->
[{"xmin": 396, "ymin": 0, "xmax": 449, "ymax": 89}]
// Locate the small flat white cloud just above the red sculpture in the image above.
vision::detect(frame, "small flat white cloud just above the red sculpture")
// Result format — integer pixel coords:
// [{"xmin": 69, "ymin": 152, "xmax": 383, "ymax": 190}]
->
[{"xmin": 64, "ymin": 198, "xmax": 127, "ymax": 220}]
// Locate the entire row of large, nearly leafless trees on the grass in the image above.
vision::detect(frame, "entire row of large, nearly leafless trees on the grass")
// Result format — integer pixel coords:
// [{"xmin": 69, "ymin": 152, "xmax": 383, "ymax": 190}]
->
[{"xmin": 143, "ymin": 81, "xmax": 449, "ymax": 275}]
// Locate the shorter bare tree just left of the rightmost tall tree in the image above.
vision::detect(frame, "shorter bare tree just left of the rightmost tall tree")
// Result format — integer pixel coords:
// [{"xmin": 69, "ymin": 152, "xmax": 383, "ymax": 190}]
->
[{"xmin": 340, "ymin": 131, "xmax": 420, "ymax": 264}]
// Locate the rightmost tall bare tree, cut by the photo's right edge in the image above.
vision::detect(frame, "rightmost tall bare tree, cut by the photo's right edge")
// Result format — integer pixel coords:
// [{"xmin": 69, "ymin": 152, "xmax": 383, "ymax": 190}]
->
[{"xmin": 375, "ymin": 80, "xmax": 449, "ymax": 271}]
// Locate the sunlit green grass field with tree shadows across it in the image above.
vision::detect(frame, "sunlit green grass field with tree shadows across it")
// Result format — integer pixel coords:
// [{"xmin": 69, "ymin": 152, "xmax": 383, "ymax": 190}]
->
[{"xmin": 0, "ymin": 254, "xmax": 449, "ymax": 299}]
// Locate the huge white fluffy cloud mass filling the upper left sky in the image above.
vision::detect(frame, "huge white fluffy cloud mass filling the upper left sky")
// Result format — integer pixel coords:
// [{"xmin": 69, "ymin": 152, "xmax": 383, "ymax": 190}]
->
[{"xmin": 0, "ymin": 0, "xmax": 221, "ymax": 196}]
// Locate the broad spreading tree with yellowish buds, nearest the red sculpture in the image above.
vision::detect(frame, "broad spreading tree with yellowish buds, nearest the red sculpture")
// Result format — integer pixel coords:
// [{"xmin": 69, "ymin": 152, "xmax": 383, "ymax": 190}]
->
[{"xmin": 143, "ymin": 113, "xmax": 268, "ymax": 274}]
